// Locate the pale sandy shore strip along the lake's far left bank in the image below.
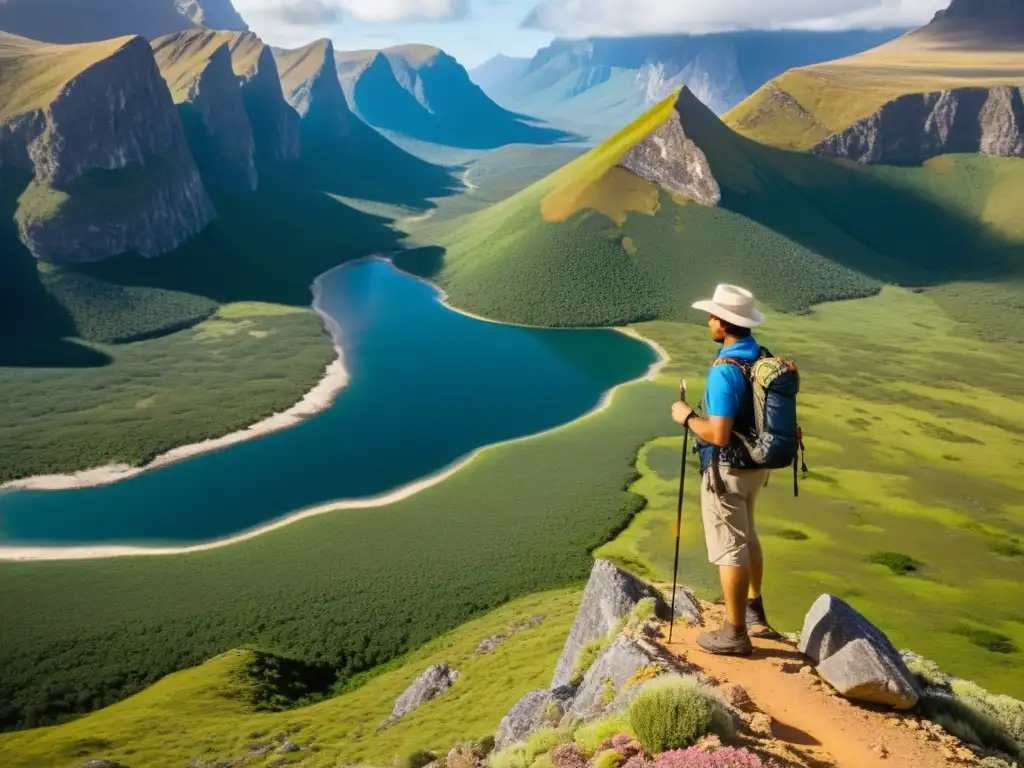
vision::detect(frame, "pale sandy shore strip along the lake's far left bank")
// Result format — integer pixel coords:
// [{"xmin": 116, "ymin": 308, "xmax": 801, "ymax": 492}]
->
[{"xmin": 0, "ymin": 264, "xmax": 349, "ymax": 495}]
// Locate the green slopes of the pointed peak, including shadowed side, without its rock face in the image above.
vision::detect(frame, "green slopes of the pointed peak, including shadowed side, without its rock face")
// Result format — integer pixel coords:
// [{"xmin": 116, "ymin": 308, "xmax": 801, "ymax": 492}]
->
[{"xmin": 400, "ymin": 88, "xmax": 1024, "ymax": 333}]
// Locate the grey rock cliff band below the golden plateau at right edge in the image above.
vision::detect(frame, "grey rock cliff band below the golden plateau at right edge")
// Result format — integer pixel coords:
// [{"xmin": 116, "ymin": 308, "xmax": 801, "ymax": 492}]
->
[{"xmin": 813, "ymin": 86, "xmax": 1024, "ymax": 165}]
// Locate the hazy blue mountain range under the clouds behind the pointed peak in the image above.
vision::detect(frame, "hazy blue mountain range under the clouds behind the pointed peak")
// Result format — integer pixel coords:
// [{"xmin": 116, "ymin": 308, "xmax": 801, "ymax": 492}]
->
[{"xmin": 470, "ymin": 29, "xmax": 905, "ymax": 137}]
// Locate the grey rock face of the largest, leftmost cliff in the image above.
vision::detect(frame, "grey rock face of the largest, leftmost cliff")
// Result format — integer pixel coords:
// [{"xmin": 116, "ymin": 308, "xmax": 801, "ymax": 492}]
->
[{"xmin": 0, "ymin": 38, "xmax": 215, "ymax": 262}]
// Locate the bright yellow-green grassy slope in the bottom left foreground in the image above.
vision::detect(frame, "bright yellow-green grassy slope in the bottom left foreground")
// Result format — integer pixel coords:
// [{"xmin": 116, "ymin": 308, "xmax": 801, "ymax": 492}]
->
[{"xmin": 0, "ymin": 591, "xmax": 579, "ymax": 768}]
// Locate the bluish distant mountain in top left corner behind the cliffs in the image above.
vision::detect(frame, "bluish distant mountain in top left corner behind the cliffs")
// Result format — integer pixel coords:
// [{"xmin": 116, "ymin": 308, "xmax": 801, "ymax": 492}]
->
[{"xmin": 0, "ymin": 0, "xmax": 249, "ymax": 43}]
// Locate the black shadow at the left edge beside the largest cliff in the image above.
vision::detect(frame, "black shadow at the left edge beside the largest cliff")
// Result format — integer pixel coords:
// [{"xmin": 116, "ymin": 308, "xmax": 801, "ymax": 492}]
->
[{"xmin": 0, "ymin": 169, "xmax": 111, "ymax": 368}]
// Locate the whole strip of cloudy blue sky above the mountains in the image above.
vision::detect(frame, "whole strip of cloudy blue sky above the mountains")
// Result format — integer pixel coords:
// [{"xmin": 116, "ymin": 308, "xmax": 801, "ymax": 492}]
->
[{"xmin": 233, "ymin": 0, "xmax": 948, "ymax": 68}]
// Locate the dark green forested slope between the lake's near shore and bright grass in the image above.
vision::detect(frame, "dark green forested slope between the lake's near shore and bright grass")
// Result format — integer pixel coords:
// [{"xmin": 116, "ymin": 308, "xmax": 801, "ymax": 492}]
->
[{"xmin": 0, "ymin": 384, "xmax": 672, "ymax": 725}]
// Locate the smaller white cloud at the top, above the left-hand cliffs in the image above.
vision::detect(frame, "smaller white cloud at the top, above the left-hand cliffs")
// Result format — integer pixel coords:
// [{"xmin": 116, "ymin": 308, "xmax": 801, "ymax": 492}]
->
[{"xmin": 234, "ymin": 0, "xmax": 469, "ymax": 27}]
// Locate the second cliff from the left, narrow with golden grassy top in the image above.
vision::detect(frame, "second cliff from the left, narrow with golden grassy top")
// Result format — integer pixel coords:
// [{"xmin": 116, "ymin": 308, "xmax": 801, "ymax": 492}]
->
[{"xmin": 153, "ymin": 30, "xmax": 257, "ymax": 191}]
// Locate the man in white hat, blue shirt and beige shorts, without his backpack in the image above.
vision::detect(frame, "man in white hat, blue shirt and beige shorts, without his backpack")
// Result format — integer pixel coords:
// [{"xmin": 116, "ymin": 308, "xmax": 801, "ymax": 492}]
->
[{"xmin": 672, "ymin": 285, "xmax": 779, "ymax": 654}]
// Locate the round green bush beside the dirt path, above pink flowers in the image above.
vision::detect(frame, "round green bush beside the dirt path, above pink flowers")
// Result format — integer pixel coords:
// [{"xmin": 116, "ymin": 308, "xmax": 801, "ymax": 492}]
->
[{"xmin": 629, "ymin": 677, "xmax": 733, "ymax": 754}]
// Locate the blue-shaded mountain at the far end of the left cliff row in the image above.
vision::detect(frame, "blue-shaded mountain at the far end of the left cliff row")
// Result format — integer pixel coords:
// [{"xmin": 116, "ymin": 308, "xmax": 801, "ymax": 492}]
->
[{"xmin": 337, "ymin": 45, "xmax": 567, "ymax": 148}]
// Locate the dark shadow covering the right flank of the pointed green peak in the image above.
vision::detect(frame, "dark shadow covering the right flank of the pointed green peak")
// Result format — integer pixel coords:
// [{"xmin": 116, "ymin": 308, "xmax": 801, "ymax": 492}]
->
[{"xmin": 677, "ymin": 94, "xmax": 1024, "ymax": 287}]
